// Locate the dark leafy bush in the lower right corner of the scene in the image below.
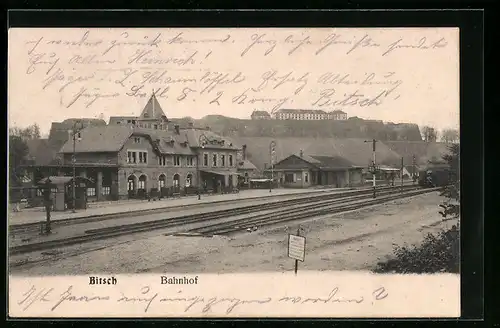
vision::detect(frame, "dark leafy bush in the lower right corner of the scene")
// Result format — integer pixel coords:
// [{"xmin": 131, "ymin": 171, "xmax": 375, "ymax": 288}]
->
[{"xmin": 374, "ymin": 226, "xmax": 460, "ymax": 273}]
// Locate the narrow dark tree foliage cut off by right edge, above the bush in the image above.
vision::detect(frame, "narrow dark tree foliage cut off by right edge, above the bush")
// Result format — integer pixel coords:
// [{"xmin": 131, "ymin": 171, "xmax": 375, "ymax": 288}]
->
[{"xmin": 439, "ymin": 144, "xmax": 460, "ymax": 220}]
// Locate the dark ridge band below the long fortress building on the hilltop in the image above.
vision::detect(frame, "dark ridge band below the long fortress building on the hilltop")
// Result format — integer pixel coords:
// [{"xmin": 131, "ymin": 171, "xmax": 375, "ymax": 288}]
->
[{"xmin": 174, "ymin": 115, "xmax": 422, "ymax": 141}]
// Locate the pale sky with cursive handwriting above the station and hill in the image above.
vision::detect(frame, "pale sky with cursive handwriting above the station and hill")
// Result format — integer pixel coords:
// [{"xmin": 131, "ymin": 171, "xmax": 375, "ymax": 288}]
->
[{"xmin": 8, "ymin": 28, "xmax": 459, "ymax": 133}]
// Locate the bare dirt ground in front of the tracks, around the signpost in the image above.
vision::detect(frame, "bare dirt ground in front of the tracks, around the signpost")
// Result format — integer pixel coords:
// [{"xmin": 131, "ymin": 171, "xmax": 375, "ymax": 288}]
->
[{"xmin": 11, "ymin": 193, "xmax": 455, "ymax": 275}]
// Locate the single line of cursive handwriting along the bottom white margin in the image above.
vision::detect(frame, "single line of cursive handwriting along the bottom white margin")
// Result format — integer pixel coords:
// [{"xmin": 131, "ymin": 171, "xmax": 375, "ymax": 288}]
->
[{"xmin": 17, "ymin": 286, "xmax": 389, "ymax": 314}]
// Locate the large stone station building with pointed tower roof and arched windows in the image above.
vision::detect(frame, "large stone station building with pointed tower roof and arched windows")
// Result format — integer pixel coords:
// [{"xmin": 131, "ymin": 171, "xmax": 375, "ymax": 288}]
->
[{"xmin": 23, "ymin": 94, "xmax": 240, "ymax": 201}]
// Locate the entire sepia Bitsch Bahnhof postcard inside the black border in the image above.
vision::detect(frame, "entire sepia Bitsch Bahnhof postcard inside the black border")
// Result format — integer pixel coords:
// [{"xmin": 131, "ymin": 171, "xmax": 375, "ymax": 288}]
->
[{"xmin": 7, "ymin": 27, "xmax": 460, "ymax": 317}]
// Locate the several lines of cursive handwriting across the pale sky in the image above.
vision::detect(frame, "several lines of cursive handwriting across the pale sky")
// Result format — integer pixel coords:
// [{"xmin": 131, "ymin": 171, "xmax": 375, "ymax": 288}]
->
[{"xmin": 15, "ymin": 29, "xmax": 448, "ymax": 112}]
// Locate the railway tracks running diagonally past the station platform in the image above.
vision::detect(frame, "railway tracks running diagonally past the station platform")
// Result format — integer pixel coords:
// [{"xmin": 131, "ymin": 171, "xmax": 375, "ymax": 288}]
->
[{"xmin": 9, "ymin": 186, "xmax": 432, "ymax": 255}]
